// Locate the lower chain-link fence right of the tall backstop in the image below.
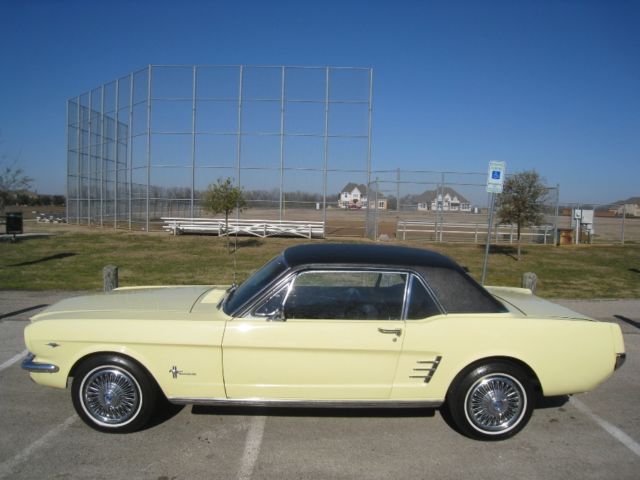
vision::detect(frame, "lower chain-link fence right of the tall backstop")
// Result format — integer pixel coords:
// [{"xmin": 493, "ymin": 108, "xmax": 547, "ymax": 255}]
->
[{"xmin": 367, "ymin": 174, "xmax": 640, "ymax": 245}]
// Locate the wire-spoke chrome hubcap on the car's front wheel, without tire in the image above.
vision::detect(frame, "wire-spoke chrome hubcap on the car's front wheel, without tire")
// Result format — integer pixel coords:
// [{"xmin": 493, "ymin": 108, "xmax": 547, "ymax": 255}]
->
[{"xmin": 81, "ymin": 367, "xmax": 141, "ymax": 425}]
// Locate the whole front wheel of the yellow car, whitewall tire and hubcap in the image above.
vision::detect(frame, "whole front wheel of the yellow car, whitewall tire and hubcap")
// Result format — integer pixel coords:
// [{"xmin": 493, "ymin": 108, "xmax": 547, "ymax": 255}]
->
[{"xmin": 71, "ymin": 355, "xmax": 157, "ymax": 433}]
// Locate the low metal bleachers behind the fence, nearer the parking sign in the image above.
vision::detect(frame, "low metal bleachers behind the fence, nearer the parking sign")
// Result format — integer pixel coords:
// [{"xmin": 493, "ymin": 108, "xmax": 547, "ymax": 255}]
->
[{"xmin": 396, "ymin": 220, "xmax": 554, "ymax": 245}]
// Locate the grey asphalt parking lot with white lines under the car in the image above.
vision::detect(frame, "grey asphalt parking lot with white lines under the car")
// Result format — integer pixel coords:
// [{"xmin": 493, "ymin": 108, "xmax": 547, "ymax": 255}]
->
[{"xmin": 0, "ymin": 291, "xmax": 640, "ymax": 480}]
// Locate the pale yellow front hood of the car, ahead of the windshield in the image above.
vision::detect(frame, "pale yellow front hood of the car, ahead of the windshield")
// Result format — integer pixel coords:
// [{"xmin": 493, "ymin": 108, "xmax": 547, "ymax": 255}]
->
[{"xmin": 31, "ymin": 286, "xmax": 224, "ymax": 322}]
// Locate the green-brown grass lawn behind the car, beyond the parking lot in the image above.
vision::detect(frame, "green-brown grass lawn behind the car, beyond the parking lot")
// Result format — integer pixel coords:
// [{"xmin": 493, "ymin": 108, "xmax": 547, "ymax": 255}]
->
[{"xmin": 0, "ymin": 223, "xmax": 640, "ymax": 298}]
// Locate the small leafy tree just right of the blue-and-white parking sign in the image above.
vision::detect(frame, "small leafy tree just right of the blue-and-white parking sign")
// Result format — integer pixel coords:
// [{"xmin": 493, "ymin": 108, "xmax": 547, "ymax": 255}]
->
[{"xmin": 498, "ymin": 170, "xmax": 548, "ymax": 261}]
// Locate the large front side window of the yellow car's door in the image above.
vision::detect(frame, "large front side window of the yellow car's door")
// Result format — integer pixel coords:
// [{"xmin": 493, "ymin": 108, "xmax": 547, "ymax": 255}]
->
[{"xmin": 284, "ymin": 270, "xmax": 407, "ymax": 320}]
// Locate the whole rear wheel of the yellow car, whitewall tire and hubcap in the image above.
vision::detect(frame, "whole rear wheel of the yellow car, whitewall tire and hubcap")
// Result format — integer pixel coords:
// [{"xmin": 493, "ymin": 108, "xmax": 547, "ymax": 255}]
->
[{"xmin": 447, "ymin": 362, "xmax": 533, "ymax": 440}]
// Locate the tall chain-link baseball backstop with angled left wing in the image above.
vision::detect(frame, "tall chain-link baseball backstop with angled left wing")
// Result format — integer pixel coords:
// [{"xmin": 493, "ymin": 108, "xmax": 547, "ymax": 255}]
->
[{"xmin": 67, "ymin": 65, "xmax": 373, "ymax": 233}]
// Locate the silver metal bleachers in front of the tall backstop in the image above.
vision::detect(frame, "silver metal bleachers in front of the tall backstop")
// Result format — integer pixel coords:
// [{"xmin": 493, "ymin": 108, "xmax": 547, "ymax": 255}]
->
[{"xmin": 162, "ymin": 217, "xmax": 325, "ymax": 238}]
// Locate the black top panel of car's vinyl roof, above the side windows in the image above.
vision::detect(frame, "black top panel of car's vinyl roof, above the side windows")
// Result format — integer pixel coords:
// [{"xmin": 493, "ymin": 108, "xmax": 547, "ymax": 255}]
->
[{"xmin": 282, "ymin": 243, "xmax": 463, "ymax": 271}]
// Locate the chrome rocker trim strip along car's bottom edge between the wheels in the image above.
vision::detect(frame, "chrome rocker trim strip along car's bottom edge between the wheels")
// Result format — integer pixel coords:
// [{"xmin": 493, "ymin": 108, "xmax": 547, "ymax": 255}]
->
[{"xmin": 168, "ymin": 397, "xmax": 444, "ymax": 408}]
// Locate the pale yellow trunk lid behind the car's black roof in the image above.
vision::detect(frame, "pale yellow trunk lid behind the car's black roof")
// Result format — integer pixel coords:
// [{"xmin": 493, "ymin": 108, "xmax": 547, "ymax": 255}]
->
[{"xmin": 486, "ymin": 287, "xmax": 595, "ymax": 321}]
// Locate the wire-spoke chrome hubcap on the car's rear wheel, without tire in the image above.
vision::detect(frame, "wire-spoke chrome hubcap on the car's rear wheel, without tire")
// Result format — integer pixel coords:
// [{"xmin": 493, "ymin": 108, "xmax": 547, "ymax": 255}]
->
[{"xmin": 465, "ymin": 374, "xmax": 527, "ymax": 434}]
